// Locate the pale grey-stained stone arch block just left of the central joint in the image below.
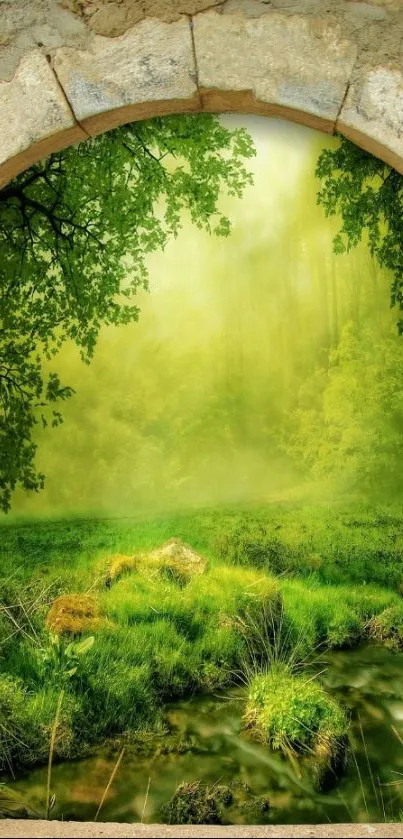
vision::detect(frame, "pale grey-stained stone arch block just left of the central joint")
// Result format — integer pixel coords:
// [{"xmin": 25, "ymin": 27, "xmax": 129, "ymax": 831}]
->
[{"xmin": 53, "ymin": 20, "xmax": 198, "ymax": 133}]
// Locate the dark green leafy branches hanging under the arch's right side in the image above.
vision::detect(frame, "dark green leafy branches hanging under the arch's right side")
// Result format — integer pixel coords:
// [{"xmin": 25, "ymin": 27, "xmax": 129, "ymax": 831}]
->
[{"xmin": 316, "ymin": 137, "xmax": 403, "ymax": 334}]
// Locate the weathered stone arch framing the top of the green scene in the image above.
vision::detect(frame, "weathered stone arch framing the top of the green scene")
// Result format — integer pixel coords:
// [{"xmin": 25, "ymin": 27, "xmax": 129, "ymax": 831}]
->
[{"xmin": 0, "ymin": 0, "xmax": 403, "ymax": 186}]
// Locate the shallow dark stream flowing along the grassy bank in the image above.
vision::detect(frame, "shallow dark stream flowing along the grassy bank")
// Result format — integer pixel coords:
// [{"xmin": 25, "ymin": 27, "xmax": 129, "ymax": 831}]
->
[{"xmin": 10, "ymin": 646, "xmax": 403, "ymax": 824}]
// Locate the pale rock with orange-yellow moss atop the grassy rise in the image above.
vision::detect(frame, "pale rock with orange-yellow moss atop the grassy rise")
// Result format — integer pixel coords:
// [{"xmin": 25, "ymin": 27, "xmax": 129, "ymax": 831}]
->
[{"xmin": 106, "ymin": 539, "xmax": 207, "ymax": 586}]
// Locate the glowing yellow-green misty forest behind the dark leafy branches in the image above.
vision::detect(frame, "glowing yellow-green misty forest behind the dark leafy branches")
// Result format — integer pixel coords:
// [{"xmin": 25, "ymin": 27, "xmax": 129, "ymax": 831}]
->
[{"xmin": 7, "ymin": 117, "xmax": 403, "ymax": 515}]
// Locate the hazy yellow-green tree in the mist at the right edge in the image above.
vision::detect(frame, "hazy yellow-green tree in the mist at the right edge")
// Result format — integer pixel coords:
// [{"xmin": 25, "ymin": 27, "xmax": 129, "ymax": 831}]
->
[{"xmin": 287, "ymin": 321, "xmax": 403, "ymax": 497}]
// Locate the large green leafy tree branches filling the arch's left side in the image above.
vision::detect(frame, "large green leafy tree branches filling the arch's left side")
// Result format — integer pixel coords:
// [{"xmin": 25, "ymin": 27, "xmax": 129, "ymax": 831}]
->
[{"xmin": 0, "ymin": 115, "xmax": 255, "ymax": 511}]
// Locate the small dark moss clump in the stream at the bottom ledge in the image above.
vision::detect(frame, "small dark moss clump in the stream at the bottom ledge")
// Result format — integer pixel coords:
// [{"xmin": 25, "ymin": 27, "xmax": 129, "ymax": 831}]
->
[{"xmin": 162, "ymin": 781, "xmax": 222, "ymax": 824}]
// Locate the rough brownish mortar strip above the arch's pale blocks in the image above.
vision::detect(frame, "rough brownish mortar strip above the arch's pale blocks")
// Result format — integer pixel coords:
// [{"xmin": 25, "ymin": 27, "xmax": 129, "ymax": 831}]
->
[{"xmin": 0, "ymin": 0, "xmax": 403, "ymax": 80}]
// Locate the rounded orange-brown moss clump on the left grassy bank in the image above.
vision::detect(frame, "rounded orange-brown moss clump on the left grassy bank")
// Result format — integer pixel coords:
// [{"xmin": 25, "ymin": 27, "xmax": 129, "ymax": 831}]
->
[{"xmin": 46, "ymin": 594, "xmax": 105, "ymax": 635}]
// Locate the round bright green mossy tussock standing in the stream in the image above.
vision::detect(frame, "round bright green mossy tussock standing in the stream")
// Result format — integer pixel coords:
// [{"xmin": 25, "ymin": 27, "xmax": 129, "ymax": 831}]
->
[{"xmin": 245, "ymin": 665, "xmax": 348, "ymax": 787}]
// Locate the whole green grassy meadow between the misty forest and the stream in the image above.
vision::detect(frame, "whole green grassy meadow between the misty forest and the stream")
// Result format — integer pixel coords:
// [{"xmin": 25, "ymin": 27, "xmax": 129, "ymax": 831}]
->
[{"xmin": 0, "ymin": 505, "xmax": 403, "ymax": 772}]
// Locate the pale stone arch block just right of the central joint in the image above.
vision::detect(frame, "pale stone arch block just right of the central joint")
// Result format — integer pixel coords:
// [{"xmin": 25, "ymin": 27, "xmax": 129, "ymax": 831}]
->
[{"xmin": 194, "ymin": 11, "xmax": 356, "ymax": 129}]
